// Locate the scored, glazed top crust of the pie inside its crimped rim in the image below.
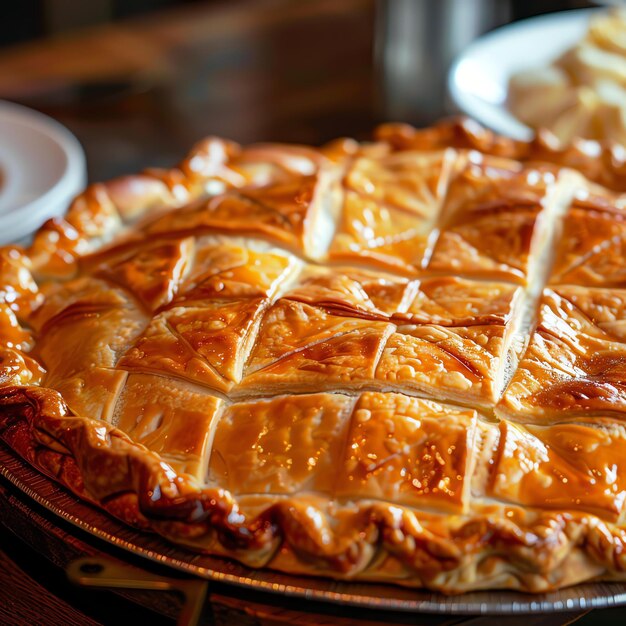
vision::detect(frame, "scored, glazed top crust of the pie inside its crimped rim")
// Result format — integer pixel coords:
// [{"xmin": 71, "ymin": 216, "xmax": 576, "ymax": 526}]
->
[{"xmin": 24, "ymin": 123, "xmax": 626, "ymax": 521}]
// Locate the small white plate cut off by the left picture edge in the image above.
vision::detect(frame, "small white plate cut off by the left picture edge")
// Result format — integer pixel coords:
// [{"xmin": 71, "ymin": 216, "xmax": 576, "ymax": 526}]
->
[{"xmin": 0, "ymin": 101, "xmax": 87, "ymax": 244}]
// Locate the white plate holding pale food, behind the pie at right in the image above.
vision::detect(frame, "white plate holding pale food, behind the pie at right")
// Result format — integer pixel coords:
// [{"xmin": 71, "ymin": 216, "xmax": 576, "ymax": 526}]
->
[{"xmin": 448, "ymin": 9, "xmax": 601, "ymax": 139}]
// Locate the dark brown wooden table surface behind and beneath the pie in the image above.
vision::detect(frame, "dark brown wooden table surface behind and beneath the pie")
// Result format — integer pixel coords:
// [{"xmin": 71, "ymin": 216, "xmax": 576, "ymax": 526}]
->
[{"xmin": 0, "ymin": 0, "xmax": 626, "ymax": 626}]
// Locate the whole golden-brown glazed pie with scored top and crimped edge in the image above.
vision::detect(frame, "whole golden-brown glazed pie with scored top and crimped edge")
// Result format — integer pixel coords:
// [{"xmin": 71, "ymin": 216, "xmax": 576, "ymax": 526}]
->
[{"xmin": 0, "ymin": 120, "xmax": 626, "ymax": 593}]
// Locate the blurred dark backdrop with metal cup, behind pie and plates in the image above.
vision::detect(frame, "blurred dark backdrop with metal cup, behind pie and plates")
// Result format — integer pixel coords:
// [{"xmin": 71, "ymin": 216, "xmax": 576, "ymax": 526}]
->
[{"xmin": 0, "ymin": 0, "xmax": 593, "ymax": 180}]
